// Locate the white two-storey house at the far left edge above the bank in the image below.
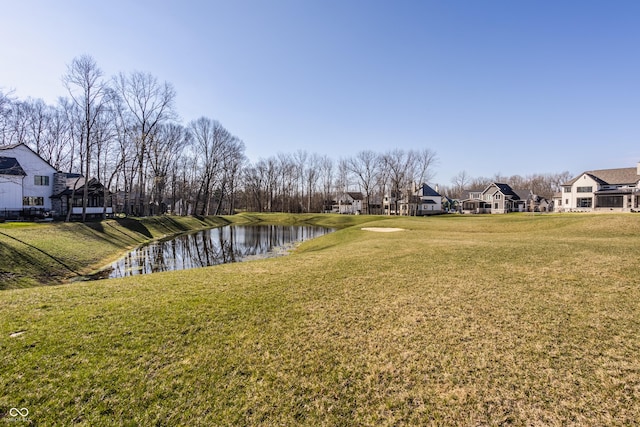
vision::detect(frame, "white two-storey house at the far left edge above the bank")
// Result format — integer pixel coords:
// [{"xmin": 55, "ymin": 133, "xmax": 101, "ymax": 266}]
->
[{"xmin": 0, "ymin": 144, "xmax": 56, "ymax": 216}]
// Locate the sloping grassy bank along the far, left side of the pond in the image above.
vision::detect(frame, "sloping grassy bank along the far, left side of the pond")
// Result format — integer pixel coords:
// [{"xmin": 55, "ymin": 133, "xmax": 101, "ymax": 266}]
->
[{"xmin": 0, "ymin": 214, "xmax": 370, "ymax": 290}]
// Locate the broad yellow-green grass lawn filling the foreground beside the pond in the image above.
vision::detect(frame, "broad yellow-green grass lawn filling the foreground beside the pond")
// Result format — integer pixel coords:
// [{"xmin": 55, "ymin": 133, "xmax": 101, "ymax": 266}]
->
[{"xmin": 0, "ymin": 214, "xmax": 640, "ymax": 426}]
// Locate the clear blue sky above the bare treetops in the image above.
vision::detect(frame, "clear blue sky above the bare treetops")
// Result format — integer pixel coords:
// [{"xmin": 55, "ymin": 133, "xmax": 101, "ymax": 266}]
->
[{"xmin": 0, "ymin": 0, "xmax": 640, "ymax": 185}]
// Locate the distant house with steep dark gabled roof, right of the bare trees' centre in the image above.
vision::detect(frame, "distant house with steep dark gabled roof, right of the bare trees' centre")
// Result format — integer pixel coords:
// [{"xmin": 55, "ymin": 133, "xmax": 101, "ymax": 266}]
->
[{"xmin": 461, "ymin": 182, "xmax": 531, "ymax": 214}]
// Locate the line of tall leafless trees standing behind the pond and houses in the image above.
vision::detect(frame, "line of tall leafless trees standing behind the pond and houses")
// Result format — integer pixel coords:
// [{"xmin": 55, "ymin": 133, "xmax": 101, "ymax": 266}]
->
[{"xmin": 0, "ymin": 55, "xmax": 570, "ymax": 216}]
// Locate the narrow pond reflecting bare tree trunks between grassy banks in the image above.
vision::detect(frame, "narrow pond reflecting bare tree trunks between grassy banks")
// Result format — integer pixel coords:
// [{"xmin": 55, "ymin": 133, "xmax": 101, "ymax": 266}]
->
[{"xmin": 100, "ymin": 225, "xmax": 334, "ymax": 279}]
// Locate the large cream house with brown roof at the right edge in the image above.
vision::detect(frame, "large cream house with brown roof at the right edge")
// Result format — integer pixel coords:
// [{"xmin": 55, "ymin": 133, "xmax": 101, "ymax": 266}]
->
[{"xmin": 554, "ymin": 162, "xmax": 640, "ymax": 212}]
